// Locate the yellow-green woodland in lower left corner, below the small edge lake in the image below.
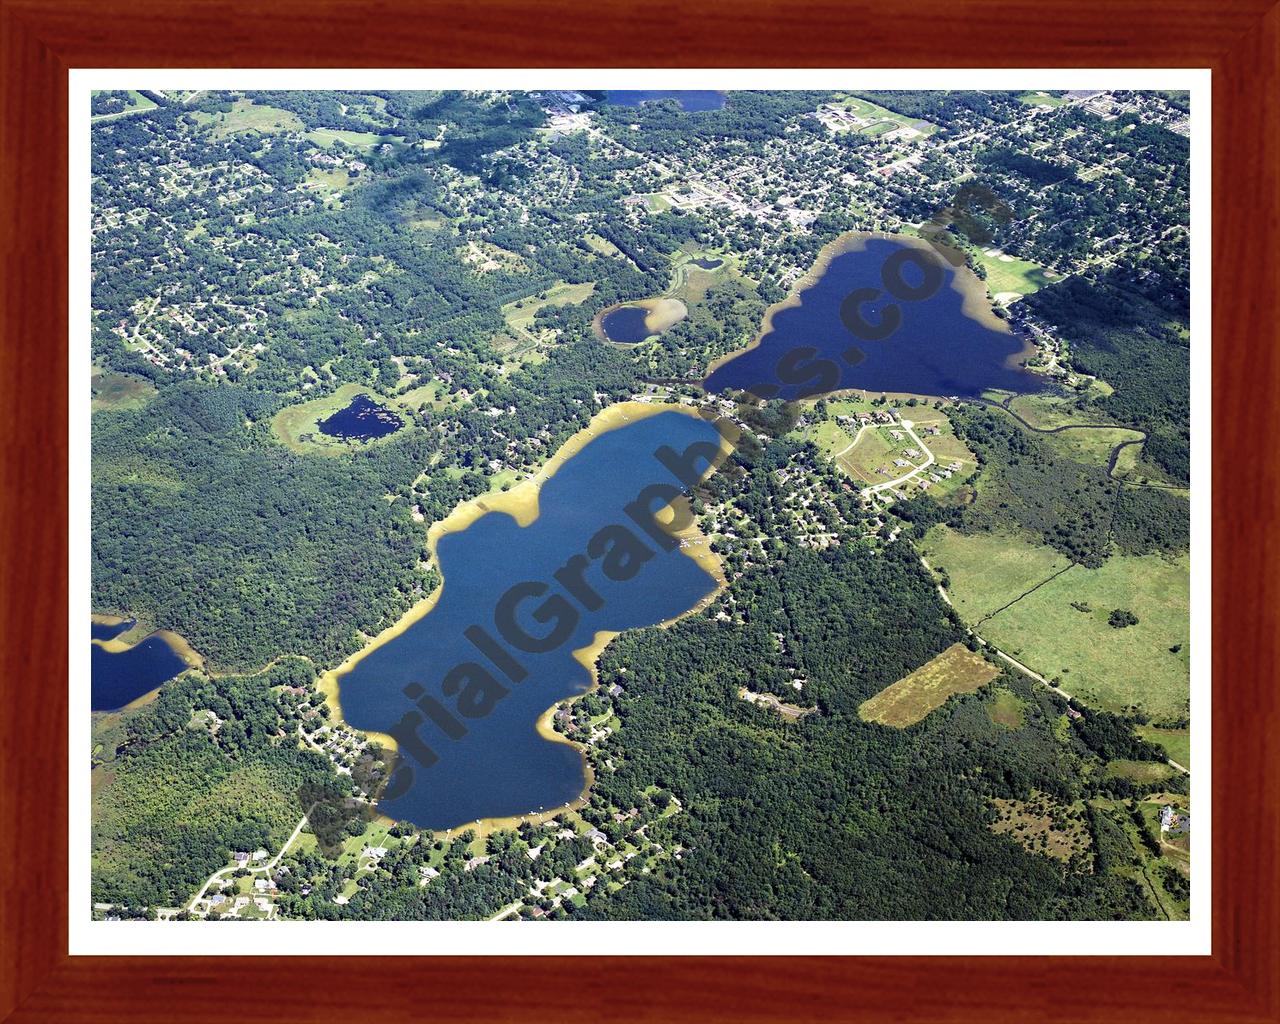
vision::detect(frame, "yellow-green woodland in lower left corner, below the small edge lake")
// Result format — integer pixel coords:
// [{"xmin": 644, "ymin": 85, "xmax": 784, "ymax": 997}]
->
[{"xmin": 93, "ymin": 658, "xmax": 351, "ymax": 908}]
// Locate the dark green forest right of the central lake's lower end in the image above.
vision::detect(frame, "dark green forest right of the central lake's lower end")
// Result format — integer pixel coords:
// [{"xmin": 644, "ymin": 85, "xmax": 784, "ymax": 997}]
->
[{"xmin": 570, "ymin": 548, "xmax": 1151, "ymax": 919}]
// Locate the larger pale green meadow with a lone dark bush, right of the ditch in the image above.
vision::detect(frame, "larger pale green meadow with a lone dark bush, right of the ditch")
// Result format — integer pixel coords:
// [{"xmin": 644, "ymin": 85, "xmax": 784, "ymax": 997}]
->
[{"xmin": 977, "ymin": 545, "xmax": 1190, "ymax": 721}]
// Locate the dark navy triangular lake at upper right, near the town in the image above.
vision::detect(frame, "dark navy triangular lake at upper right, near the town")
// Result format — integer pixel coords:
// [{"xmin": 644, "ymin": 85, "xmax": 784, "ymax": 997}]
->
[{"xmin": 705, "ymin": 238, "xmax": 1046, "ymax": 398}]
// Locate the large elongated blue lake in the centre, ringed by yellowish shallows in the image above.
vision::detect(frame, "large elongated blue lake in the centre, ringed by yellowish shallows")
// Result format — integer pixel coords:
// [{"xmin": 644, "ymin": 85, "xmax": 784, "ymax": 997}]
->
[{"xmin": 339, "ymin": 412, "xmax": 718, "ymax": 829}]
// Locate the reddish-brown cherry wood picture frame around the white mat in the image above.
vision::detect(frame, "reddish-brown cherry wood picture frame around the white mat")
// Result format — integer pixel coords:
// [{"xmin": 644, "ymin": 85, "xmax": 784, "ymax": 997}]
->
[{"xmin": 0, "ymin": 0, "xmax": 1280, "ymax": 1024}]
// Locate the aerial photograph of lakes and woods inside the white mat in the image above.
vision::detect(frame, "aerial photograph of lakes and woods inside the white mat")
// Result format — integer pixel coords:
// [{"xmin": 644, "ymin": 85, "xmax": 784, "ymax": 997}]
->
[{"xmin": 87, "ymin": 85, "xmax": 1187, "ymax": 934}]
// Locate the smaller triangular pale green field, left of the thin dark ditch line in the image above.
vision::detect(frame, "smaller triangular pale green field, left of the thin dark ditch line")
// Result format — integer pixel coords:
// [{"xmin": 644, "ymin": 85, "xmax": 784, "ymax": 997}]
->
[{"xmin": 920, "ymin": 526, "xmax": 1070, "ymax": 626}]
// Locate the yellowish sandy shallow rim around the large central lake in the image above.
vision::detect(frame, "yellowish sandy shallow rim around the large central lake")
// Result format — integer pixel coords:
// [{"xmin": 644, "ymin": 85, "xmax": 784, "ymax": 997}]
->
[{"xmin": 316, "ymin": 402, "xmax": 733, "ymax": 836}]
